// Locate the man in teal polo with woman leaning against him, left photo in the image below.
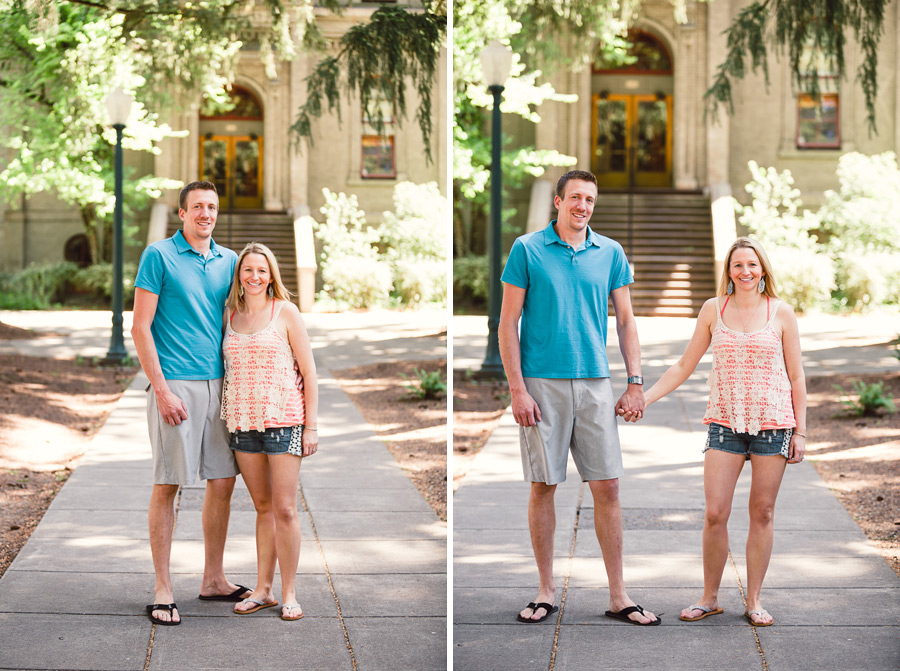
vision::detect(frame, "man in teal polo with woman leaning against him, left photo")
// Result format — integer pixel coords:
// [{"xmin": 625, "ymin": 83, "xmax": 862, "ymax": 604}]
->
[{"xmin": 131, "ymin": 182, "xmax": 251, "ymax": 625}]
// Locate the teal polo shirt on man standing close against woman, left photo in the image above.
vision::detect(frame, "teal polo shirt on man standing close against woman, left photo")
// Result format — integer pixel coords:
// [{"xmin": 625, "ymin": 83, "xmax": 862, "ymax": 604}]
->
[{"xmin": 134, "ymin": 231, "xmax": 237, "ymax": 380}]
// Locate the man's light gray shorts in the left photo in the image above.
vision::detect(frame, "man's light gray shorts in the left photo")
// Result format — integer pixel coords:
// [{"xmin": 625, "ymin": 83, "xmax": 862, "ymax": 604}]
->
[{"xmin": 147, "ymin": 378, "xmax": 240, "ymax": 485}]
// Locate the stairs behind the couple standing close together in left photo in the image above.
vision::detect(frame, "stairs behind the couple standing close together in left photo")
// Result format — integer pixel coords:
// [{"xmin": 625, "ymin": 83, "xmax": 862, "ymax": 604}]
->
[{"xmin": 168, "ymin": 211, "xmax": 298, "ymax": 296}]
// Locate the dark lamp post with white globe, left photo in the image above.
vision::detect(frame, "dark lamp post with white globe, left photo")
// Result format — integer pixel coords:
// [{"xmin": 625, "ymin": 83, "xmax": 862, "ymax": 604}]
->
[{"xmin": 103, "ymin": 86, "xmax": 134, "ymax": 365}]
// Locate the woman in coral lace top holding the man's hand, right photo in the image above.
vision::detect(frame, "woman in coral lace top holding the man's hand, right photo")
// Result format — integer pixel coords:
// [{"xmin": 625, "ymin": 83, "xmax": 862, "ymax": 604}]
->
[{"xmin": 645, "ymin": 238, "xmax": 806, "ymax": 627}]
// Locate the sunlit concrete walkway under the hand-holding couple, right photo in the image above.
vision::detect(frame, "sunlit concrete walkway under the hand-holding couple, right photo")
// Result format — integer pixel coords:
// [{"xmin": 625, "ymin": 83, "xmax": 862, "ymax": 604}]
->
[{"xmin": 453, "ymin": 316, "xmax": 900, "ymax": 671}]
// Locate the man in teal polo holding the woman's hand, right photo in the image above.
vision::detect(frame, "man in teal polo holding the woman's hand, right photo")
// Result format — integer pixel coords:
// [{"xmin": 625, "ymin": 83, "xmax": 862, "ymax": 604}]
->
[{"xmin": 499, "ymin": 170, "xmax": 659, "ymax": 625}]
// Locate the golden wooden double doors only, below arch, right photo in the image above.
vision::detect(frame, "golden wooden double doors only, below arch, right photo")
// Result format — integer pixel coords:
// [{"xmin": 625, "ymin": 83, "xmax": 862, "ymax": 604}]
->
[{"xmin": 591, "ymin": 94, "xmax": 672, "ymax": 188}]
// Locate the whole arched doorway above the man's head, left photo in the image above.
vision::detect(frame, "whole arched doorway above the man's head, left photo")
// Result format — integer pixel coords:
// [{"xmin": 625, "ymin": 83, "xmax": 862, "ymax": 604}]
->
[{"xmin": 200, "ymin": 86, "xmax": 263, "ymax": 210}]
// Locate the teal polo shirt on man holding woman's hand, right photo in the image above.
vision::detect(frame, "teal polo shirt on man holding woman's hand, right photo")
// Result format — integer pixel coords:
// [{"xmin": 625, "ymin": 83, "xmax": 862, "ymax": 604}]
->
[{"xmin": 500, "ymin": 219, "xmax": 634, "ymax": 379}]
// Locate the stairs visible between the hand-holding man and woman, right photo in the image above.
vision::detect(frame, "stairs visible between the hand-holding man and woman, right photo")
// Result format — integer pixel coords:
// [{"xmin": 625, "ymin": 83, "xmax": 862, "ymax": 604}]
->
[{"xmin": 596, "ymin": 191, "xmax": 716, "ymax": 317}]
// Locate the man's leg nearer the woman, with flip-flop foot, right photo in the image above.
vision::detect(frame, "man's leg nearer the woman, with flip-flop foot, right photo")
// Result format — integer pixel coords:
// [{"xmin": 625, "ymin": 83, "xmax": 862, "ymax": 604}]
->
[{"xmin": 588, "ymin": 478, "xmax": 656, "ymax": 623}]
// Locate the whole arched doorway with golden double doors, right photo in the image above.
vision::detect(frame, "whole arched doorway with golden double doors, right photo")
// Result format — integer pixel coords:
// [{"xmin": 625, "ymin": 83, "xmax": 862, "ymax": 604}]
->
[{"xmin": 591, "ymin": 30, "xmax": 674, "ymax": 188}]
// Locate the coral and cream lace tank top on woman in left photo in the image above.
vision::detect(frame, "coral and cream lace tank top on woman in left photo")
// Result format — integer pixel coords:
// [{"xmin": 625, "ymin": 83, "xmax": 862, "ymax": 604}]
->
[{"xmin": 222, "ymin": 301, "xmax": 306, "ymax": 433}]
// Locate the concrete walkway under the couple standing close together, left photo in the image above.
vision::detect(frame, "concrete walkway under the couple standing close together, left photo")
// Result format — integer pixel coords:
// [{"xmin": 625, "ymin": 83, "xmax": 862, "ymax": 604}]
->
[{"xmin": 0, "ymin": 312, "xmax": 447, "ymax": 671}]
